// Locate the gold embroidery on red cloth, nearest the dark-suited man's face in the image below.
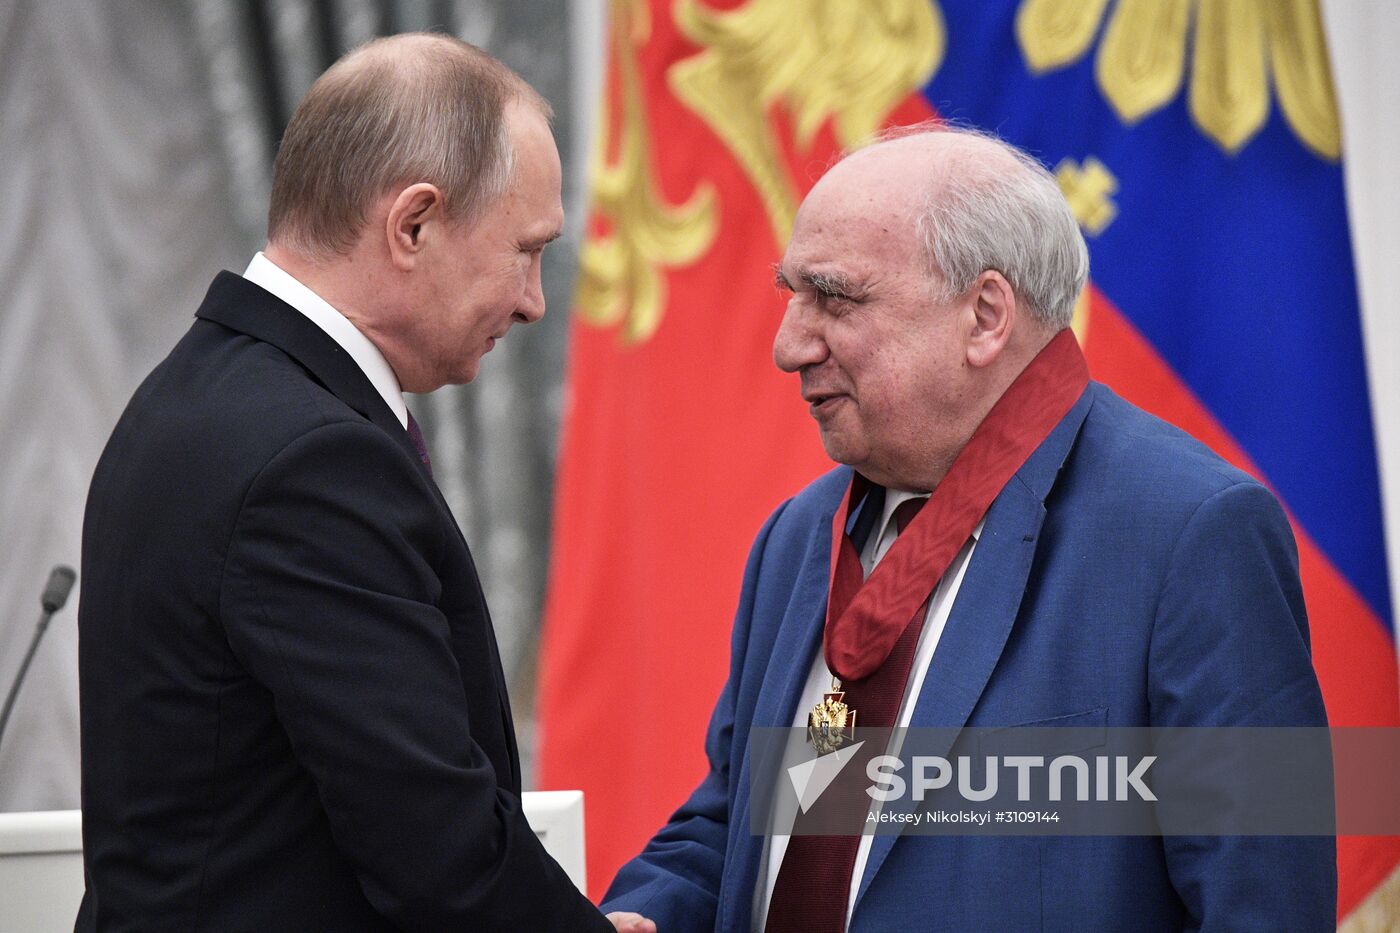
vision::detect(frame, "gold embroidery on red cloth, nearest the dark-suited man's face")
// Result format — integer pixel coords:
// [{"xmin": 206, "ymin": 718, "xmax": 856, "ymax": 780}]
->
[{"xmin": 575, "ymin": 0, "xmax": 718, "ymax": 343}]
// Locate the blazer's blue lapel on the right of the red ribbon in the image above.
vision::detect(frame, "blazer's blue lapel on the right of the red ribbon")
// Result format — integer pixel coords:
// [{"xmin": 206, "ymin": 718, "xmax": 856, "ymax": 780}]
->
[{"xmin": 855, "ymin": 382, "xmax": 1096, "ymax": 909}]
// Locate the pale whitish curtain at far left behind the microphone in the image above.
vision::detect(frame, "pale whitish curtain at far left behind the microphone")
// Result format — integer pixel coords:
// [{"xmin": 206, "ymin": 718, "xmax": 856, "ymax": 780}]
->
[{"xmin": 0, "ymin": 0, "xmax": 241, "ymax": 810}]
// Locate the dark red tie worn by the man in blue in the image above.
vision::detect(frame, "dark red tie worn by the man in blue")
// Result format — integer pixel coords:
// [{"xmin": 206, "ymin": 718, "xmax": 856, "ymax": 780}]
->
[{"xmin": 763, "ymin": 497, "xmax": 932, "ymax": 933}]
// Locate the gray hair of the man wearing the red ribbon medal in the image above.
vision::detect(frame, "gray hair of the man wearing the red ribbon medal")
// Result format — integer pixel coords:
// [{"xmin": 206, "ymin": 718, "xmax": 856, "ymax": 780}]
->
[{"xmin": 875, "ymin": 122, "xmax": 1089, "ymax": 331}]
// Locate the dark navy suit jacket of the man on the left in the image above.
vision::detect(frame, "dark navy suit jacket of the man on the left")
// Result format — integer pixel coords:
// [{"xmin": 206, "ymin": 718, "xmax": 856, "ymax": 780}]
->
[{"xmin": 77, "ymin": 272, "xmax": 612, "ymax": 932}]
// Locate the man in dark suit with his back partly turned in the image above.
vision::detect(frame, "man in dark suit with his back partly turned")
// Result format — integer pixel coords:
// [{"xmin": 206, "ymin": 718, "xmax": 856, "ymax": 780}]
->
[{"xmin": 77, "ymin": 35, "xmax": 644, "ymax": 930}]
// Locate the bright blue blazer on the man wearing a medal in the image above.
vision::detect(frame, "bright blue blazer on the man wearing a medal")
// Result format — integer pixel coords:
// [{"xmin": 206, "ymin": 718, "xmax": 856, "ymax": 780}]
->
[{"xmin": 603, "ymin": 384, "xmax": 1337, "ymax": 933}]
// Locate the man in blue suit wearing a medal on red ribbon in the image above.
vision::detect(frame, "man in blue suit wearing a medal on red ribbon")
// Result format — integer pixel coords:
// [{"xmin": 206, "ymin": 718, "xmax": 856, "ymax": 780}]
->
[{"xmin": 605, "ymin": 129, "xmax": 1337, "ymax": 933}]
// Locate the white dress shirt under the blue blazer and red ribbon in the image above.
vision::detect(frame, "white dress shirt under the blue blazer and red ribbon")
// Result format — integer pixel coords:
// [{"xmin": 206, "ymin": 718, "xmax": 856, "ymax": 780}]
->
[{"xmin": 753, "ymin": 489, "xmax": 986, "ymax": 930}]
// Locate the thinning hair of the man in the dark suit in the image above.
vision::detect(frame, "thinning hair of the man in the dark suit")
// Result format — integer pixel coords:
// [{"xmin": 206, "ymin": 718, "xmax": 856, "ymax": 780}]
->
[{"xmin": 267, "ymin": 32, "xmax": 550, "ymax": 256}]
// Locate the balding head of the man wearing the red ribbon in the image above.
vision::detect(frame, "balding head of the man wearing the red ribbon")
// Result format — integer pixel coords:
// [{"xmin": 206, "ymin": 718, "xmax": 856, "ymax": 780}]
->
[{"xmin": 773, "ymin": 121, "xmax": 1086, "ymax": 490}]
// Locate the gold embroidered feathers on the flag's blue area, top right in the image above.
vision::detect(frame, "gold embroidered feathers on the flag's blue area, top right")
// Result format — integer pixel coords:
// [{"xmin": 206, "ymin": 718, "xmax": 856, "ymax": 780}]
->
[{"xmin": 1016, "ymin": 0, "xmax": 1341, "ymax": 160}]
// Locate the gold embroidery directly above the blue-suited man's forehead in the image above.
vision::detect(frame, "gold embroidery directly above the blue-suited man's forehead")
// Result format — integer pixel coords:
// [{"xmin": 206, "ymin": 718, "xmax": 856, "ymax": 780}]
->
[{"xmin": 668, "ymin": 0, "xmax": 945, "ymax": 244}]
